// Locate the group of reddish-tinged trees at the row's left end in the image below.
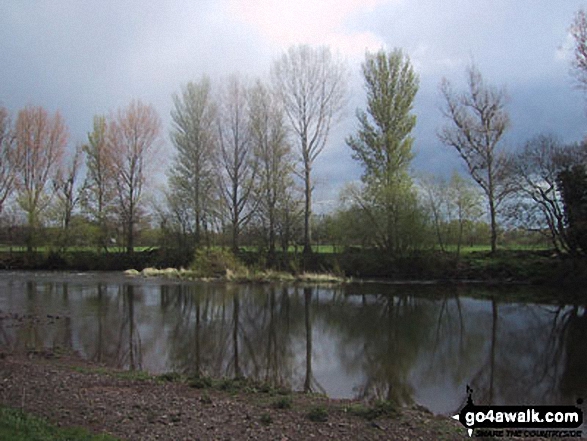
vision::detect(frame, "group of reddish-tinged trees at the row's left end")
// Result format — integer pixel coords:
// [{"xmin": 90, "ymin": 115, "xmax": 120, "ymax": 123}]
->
[{"xmin": 0, "ymin": 101, "xmax": 161, "ymax": 251}]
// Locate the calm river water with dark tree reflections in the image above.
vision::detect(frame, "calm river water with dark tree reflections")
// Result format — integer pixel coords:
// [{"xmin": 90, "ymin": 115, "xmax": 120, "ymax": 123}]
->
[{"xmin": 0, "ymin": 273, "xmax": 587, "ymax": 413}]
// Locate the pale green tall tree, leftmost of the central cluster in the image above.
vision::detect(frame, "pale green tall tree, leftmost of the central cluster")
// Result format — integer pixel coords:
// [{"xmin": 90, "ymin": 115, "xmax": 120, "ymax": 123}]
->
[{"xmin": 168, "ymin": 77, "xmax": 217, "ymax": 246}]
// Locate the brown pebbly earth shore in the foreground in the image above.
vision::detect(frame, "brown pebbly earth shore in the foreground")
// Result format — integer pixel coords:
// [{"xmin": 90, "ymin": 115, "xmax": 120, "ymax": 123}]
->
[{"xmin": 0, "ymin": 351, "xmax": 468, "ymax": 441}]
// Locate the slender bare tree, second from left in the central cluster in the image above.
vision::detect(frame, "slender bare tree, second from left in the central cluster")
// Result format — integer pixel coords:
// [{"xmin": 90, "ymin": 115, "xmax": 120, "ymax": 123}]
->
[{"xmin": 218, "ymin": 76, "xmax": 257, "ymax": 252}]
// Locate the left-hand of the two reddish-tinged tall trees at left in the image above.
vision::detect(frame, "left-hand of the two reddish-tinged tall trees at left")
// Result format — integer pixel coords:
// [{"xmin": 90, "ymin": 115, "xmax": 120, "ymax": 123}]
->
[{"xmin": 15, "ymin": 106, "xmax": 68, "ymax": 252}]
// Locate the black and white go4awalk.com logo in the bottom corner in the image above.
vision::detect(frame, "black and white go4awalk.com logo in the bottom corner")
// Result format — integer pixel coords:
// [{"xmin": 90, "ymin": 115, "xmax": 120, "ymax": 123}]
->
[{"xmin": 453, "ymin": 386, "xmax": 583, "ymax": 438}]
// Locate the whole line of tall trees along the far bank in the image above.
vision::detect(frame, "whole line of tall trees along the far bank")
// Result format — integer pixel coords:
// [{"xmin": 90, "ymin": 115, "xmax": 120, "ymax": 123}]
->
[{"xmin": 0, "ymin": 10, "xmax": 587, "ymax": 262}]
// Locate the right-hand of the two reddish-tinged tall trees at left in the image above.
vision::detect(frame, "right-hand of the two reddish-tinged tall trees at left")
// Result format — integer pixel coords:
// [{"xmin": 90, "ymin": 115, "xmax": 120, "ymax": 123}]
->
[{"xmin": 108, "ymin": 101, "xmax": 161, "ymax": 254}]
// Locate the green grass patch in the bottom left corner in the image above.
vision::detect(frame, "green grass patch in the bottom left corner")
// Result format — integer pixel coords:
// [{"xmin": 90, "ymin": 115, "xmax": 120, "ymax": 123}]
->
[{"xmin": 0, "ymin": 406, "xmax": 117, "ymax": 441}]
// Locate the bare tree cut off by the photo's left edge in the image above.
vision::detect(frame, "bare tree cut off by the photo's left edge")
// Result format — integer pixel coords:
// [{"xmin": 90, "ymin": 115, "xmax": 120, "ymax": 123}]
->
[{"xmin": 0, "ymin": 107, "xmax": 18, "ymax": 214}]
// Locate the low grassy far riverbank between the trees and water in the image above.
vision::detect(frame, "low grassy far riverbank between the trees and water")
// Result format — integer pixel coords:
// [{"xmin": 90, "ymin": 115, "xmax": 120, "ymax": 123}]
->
[{"xmin": 0, "ymin": 249, "xmax": 587, "ymax": 286}]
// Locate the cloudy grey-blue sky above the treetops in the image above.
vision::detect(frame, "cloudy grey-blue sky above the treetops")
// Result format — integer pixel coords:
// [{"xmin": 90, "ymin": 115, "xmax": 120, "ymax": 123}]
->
[{"xmin": 0, "ymin": 0, "xmax": 587, "ymax": 211}]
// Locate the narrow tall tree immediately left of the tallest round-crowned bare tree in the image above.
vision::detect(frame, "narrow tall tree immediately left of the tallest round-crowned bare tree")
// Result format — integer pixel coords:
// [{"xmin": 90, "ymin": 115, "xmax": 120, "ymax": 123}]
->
[{"xmin": 249, "ymin": 81, "xmax": 293, "ymax": 261}]
